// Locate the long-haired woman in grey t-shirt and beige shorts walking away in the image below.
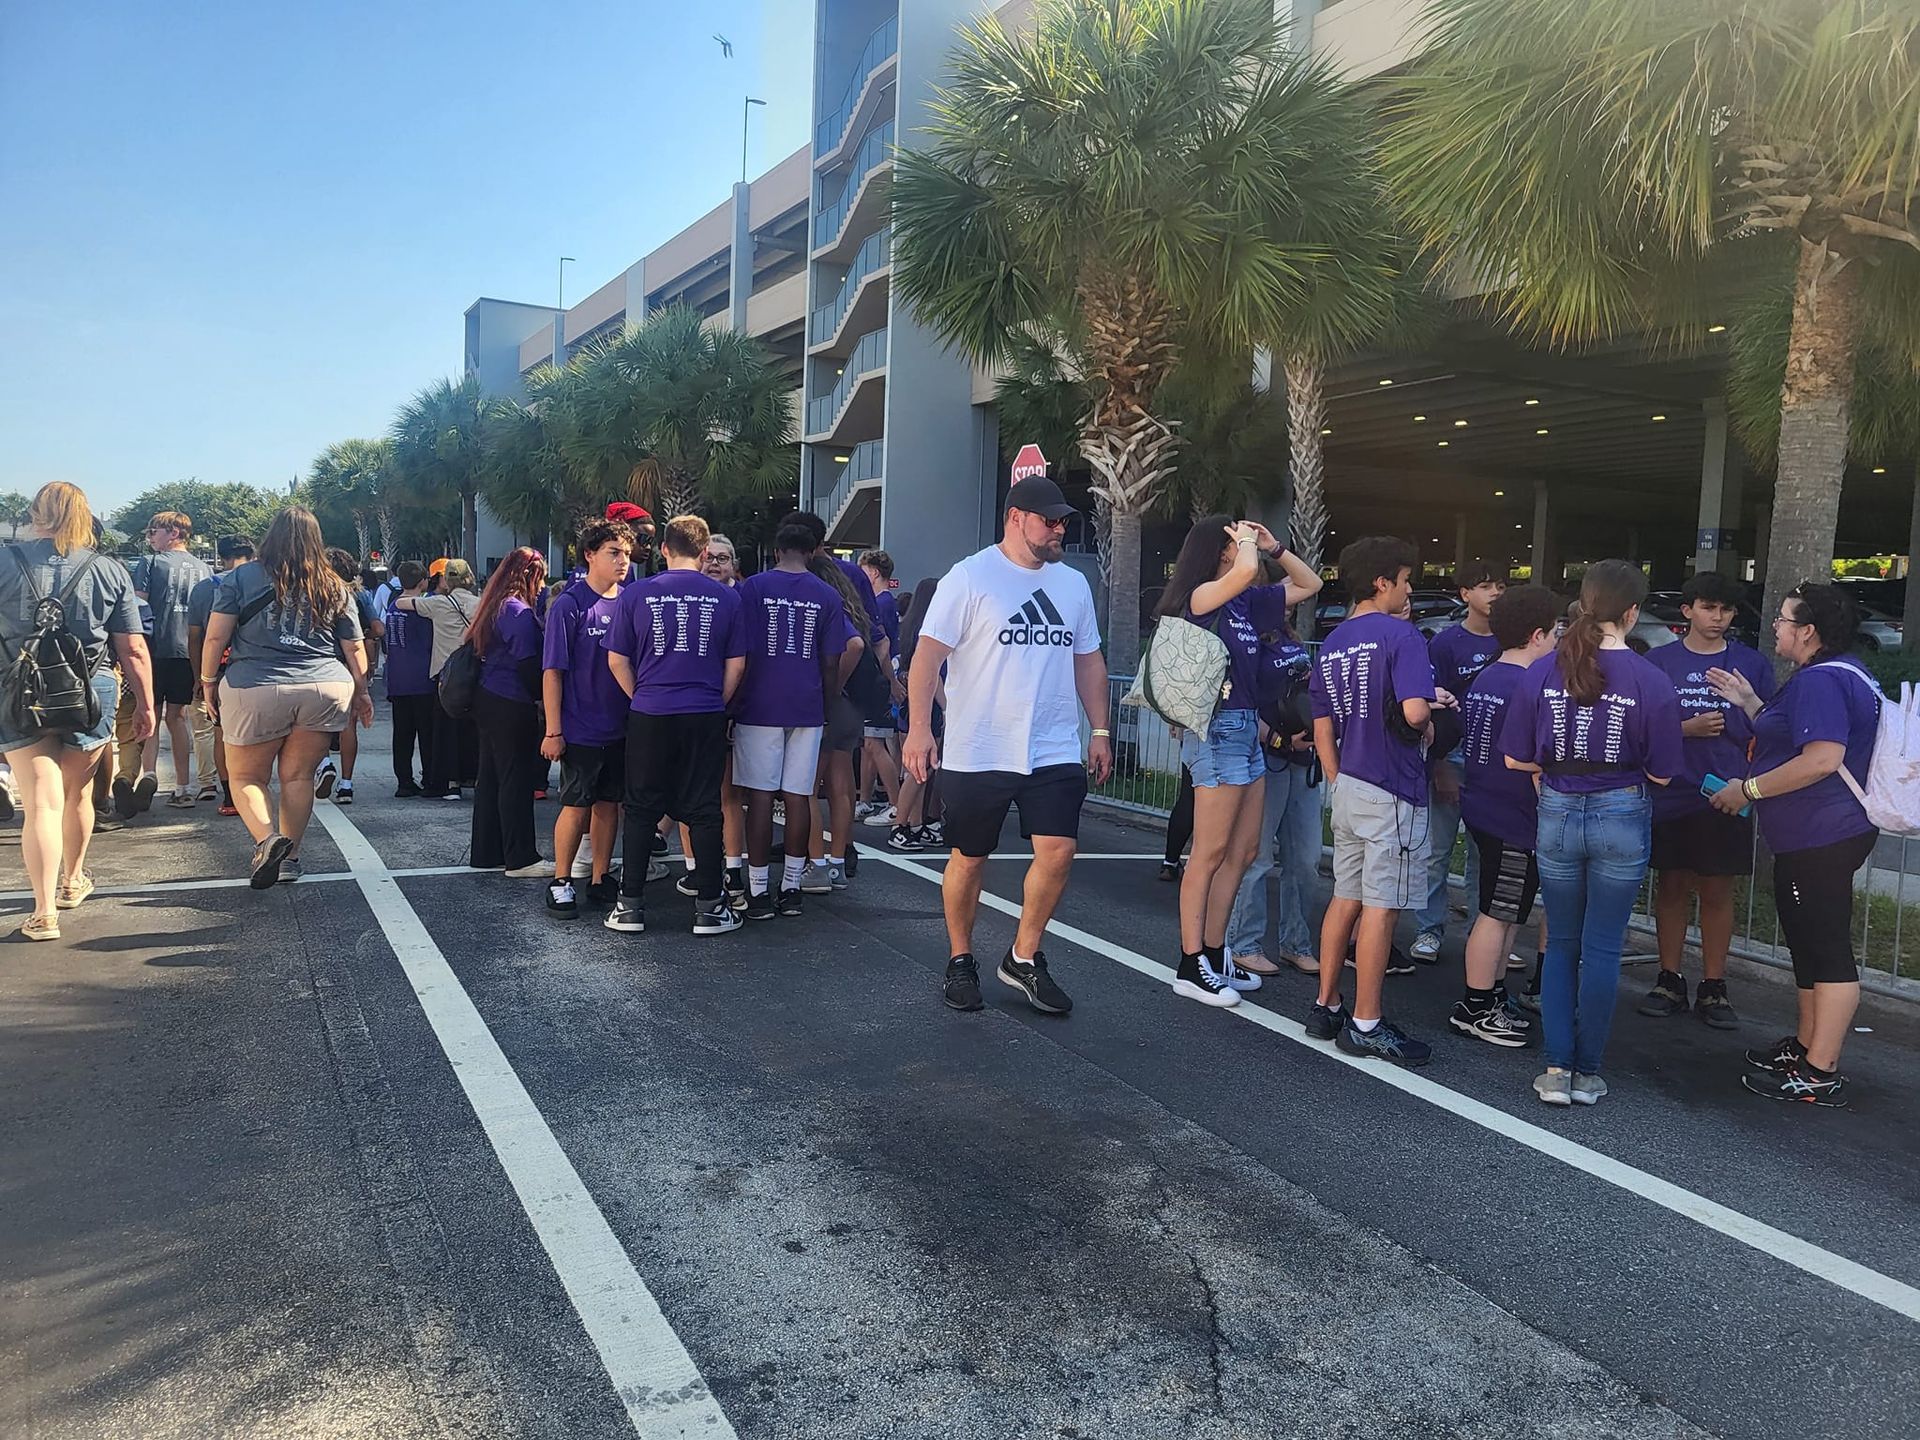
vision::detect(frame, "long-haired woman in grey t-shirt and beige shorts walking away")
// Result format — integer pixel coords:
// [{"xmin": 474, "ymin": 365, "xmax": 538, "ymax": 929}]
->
[{"xmin": 198, "ymin": 505, "xmax": 372, "ymax": 889}]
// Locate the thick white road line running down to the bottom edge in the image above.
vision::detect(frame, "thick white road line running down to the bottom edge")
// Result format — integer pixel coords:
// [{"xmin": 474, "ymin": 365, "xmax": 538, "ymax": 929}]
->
[{"xmin": 301, "ymin": 804, "xmax": 735, "ymax": 1440}]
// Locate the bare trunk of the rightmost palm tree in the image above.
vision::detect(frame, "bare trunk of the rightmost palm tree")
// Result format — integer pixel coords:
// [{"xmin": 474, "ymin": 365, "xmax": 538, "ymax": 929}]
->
[{"xmin": 1763, "ymin": 240, "xmax": 1860, "ymax": 672}]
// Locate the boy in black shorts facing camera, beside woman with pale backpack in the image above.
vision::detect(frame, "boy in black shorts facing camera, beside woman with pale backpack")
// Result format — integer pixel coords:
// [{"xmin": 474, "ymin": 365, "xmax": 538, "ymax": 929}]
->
[{"xmin": 1638, "ymin": 570, "xmax": 1774, "ymax": 1029}]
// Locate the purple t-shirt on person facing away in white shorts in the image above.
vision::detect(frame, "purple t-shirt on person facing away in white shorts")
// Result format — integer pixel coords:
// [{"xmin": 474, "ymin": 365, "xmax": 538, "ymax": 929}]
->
[{"xmin": 733, "ymin": 570, "xmax": 854, "ymax": 730}]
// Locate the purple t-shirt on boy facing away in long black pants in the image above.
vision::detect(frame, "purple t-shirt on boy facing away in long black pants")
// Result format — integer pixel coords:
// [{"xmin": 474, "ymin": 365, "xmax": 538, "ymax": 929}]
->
[{"xmin": 605, "ymin": 570, "xmax": 747, "ymax": 714}]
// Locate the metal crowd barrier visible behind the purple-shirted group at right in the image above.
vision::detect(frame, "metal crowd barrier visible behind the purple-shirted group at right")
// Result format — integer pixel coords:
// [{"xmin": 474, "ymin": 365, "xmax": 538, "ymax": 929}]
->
[{"xmin": 1081, "ymin": 676, "xmax": 1920, "ymax": 987}]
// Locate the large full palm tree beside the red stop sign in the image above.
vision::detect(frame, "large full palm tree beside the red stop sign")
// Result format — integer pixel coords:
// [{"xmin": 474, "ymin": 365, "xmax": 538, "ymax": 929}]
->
[{"xmin": 893, "ymin": 0, "xmax": 1405, "ymax": 670}]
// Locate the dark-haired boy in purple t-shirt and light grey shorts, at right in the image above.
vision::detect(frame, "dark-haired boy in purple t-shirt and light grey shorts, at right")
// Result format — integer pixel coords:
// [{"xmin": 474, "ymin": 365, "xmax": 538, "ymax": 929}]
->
[{"xmin": 1306, "ymin": 536, "xmax": 1434, "ymax": 1066}]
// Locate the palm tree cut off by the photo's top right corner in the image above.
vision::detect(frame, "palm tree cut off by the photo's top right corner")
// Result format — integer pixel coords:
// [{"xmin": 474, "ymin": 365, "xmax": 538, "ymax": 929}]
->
[{"xmin": 1384, "ymin": 0, "xmax": 1920, "ymax": 660}]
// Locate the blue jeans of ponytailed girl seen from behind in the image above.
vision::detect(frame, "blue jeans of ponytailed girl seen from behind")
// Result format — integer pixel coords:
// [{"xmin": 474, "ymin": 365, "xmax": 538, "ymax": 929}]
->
[{"xmin": 1536, "ymin": 783, "xmax": 1653, "ymax": 1075}]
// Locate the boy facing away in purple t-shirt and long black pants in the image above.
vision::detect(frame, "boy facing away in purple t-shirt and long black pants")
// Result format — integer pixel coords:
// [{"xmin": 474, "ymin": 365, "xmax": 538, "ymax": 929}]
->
[{"xmin": 605, "ymin": 515, "xmax": 747, "ymax": 935}]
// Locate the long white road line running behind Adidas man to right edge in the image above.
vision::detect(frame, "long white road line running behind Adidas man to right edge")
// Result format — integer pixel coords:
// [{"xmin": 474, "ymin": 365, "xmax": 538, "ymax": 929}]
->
[{"xmin": 860, "ymin": 847, "xmax": 1920, "ymax": 1321}]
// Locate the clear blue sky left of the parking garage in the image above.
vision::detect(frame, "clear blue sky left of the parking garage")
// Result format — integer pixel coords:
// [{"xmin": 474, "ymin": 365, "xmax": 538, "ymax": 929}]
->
[{"xmin": 0, "ymin": 0, "xmax": 812, "ymax": 513}]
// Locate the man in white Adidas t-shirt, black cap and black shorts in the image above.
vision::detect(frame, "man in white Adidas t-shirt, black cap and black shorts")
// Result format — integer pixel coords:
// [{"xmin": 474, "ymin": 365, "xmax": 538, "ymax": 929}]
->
[{"xmin": 900, "ymin": 476, "xmax": 1114, "ymax": 1016}]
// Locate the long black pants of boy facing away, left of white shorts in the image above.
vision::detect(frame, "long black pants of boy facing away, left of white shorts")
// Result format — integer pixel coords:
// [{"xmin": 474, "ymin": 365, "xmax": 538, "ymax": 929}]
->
[{"xmin": 620, "ymin": 710, "xmax": 726, "ymax": 904}]
